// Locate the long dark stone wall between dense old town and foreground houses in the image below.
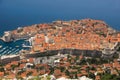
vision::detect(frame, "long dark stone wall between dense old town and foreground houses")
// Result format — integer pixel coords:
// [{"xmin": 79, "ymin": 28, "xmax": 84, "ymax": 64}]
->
[{"xmin": 26, "ymin": 49, "xmax": 102, "ymax": 58}]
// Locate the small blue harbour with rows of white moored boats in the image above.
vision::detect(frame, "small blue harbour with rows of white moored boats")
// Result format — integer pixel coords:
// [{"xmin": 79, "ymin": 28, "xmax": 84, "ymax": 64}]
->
[{"xmin": 0, "ymin": 40, "xmax": 30, "ymax": 56}]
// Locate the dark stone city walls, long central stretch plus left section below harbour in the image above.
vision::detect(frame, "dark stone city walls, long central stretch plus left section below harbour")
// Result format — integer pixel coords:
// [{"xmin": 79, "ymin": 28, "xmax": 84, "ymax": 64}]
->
[{"xmin": 0, "ymin": 46, "xmax": 118, "ymax": 64}]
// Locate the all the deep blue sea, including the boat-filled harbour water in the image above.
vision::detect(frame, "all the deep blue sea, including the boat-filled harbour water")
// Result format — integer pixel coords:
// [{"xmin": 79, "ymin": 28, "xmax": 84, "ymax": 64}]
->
[{"xmin": 0, "ymin": 0, "xmax": 120, "ymax": 55}]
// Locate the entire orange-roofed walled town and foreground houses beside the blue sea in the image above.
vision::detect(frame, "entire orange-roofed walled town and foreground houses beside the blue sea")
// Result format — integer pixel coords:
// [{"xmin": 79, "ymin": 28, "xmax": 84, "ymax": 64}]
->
[{"xmin": 0, "ymin": 19, "xmax": 120, "ymax": 80}]
